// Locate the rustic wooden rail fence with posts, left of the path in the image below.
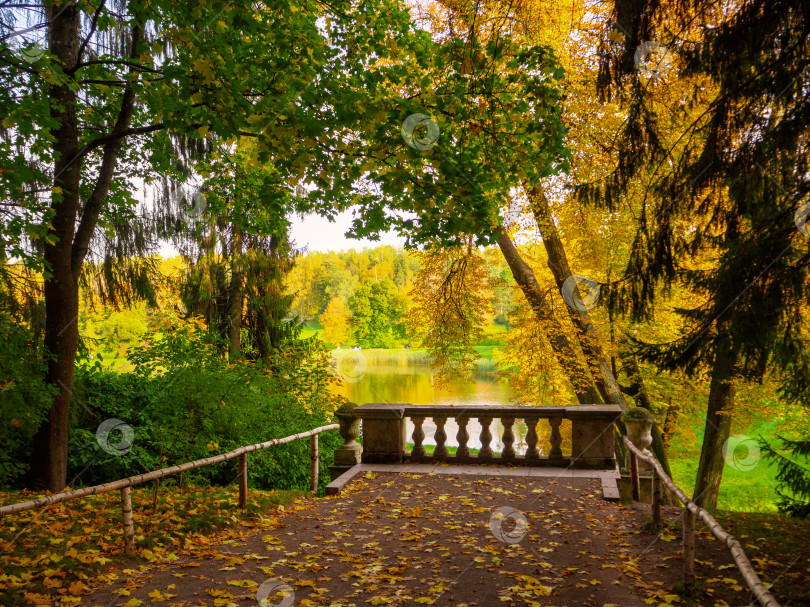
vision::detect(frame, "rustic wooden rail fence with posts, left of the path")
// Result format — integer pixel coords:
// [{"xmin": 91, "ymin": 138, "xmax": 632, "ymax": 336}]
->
[{"xmin": 0, "ymin": 424, "xmax": 340, "ymax": 554}]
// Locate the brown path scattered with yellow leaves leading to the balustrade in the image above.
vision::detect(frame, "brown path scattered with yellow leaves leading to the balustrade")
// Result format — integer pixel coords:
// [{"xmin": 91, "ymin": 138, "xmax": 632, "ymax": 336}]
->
[{"xmin": 77, "ymin": 472, "xmax": 764, "ymax": 607}]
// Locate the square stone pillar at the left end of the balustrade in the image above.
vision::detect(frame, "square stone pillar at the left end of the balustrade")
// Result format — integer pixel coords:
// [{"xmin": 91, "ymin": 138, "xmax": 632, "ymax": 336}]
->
[{"xmin": 354, "ymin": 403, "xmax": 406, "ymax": 464}]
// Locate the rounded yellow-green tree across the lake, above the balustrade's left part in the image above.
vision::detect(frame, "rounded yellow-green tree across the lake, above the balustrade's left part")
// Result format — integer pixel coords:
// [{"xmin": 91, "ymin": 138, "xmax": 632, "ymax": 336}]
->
[{"xmin": 349, "ymin": 278, "xmax": 406, "ymax": 348}]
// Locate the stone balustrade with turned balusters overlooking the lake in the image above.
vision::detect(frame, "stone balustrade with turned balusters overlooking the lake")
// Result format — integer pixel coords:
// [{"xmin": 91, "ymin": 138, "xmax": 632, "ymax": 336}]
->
[{"xmin": 354, "ymin": 403, "xmax": 622, "ymax": 469}]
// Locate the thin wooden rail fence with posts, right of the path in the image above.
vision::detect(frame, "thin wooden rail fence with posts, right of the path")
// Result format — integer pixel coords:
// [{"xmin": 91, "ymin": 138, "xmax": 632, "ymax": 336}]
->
[{"xmin": 622, "ymin": 436, "xmax": 780, "ymax": 607}]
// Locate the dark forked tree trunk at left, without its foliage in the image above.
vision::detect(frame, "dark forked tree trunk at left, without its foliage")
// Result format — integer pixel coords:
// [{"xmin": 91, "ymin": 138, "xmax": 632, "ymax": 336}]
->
[{"xmin": 28, "ymin": 9, "xmax": 142, "ymax": 491}]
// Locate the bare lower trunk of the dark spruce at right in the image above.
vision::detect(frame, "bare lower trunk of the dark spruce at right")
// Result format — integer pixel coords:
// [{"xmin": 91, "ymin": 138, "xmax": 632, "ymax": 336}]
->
[{"xmin": 692, "ymin": 334, "xmax": 736, "ymax": 509}]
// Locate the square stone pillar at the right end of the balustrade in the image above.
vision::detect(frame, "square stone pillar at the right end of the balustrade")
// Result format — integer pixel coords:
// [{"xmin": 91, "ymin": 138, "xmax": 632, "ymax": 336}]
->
[{"xmin": 566, "ymin": 405, "xmax": 622, "ymax": 469}]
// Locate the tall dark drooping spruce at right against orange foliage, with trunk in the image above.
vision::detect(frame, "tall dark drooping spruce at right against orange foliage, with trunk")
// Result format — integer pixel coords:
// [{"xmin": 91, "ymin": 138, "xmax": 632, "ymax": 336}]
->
[{"xmin": 580, "ymin": 0, "xmax": 810, "ymax": 506}]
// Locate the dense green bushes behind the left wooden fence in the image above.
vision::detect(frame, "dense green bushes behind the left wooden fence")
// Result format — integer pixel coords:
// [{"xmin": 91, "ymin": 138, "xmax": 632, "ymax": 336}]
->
[{"xmin": 62, "ymin": 326, "xmax": 340, "ymax": 496}]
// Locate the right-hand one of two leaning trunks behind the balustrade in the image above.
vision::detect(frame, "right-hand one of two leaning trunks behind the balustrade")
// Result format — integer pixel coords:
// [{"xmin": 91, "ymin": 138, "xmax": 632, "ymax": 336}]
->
[{"xmin": 525, "ymin": 185, "xmax": 629, "ymax": 411}]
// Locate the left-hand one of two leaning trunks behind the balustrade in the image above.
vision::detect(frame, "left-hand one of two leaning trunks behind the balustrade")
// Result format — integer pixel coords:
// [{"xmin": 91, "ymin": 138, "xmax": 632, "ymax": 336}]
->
[{"xmin": 498, "ymin": 229, "xmax": 602, "ymax": 404}]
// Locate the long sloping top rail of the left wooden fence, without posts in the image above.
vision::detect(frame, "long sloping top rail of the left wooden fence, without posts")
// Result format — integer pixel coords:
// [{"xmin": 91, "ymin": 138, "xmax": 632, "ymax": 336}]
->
[{"xmin": 0, "ymin": 424, "xmax": 340, "ymax": 516}]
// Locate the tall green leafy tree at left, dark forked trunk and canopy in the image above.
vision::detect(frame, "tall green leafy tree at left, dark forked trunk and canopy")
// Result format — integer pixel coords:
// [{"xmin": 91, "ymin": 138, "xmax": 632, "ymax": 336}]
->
[{"xmin": 0, "ymin": 0, "xmax": 430, "ymax": 491}]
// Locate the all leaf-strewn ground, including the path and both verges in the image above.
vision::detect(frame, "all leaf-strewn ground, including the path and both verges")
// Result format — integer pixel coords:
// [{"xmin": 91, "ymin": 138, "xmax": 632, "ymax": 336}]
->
[{"xmin": 0, "ymin": 473, "xmax": 810, "ymax": 607}]
